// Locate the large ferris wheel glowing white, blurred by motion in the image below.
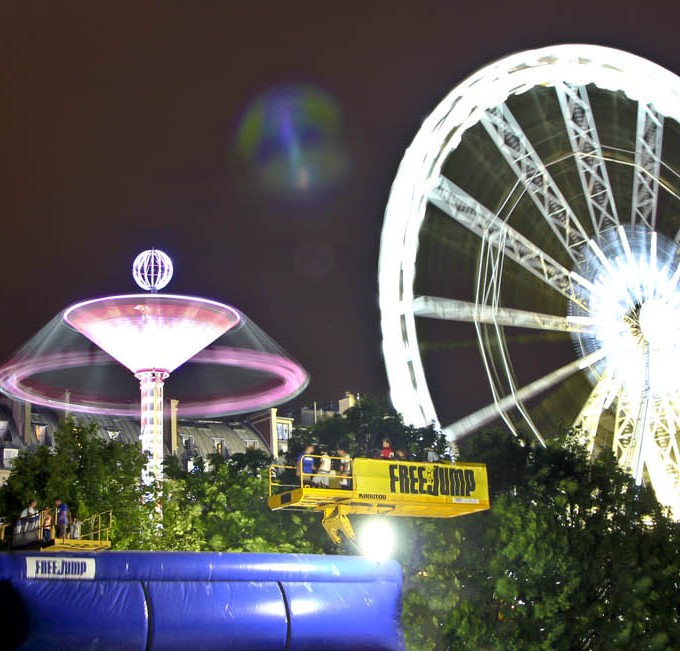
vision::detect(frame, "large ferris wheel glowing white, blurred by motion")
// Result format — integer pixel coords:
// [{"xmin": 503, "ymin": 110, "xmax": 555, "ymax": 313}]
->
[{"xmin": 379, "ymin": 45, "xmax": 680, "ymax": 517}]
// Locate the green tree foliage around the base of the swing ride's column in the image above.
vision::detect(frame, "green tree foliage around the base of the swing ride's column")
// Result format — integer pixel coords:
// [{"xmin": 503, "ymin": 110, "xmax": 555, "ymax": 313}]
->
[{"xmin": 0, "ymin": 420, "xmax": 325, "ymax": 553}]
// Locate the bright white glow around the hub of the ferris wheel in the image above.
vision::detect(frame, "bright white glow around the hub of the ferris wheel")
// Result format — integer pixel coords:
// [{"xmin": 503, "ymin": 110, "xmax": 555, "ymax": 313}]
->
[{"xmin": 572, "ymin": 227, "xmax": 680, "ymax": 403}]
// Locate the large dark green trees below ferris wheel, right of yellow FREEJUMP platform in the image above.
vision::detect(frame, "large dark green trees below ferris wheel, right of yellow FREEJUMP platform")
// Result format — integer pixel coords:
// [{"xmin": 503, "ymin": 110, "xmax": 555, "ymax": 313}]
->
[{"xmin": 401, "ymin": 432, "xmax": 680, "ymax": 650}]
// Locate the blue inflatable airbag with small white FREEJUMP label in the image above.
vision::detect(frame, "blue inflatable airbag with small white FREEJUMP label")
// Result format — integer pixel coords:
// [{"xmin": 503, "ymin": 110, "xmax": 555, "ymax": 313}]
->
[{"xmin": 0, "ymin": 552, "xmax": 404, "ymax": 651}]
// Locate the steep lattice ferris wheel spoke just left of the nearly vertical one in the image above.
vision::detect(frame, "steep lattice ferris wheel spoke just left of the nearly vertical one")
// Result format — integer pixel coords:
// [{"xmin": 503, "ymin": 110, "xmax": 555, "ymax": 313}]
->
[{"xmin": 555, "ymin": 83, "xmax": 619, "ymax": 234}]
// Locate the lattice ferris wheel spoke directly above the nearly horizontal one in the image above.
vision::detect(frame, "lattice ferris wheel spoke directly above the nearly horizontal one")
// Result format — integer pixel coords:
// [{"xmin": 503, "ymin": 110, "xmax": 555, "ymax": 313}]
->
[{"xmin": 428, "ymin": 175, "xmax": 594, "ymax": 309}]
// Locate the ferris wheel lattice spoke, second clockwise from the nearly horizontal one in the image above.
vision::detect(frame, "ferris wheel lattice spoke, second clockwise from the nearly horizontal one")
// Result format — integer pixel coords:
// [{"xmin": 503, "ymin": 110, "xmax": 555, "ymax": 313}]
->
[{"xmin": 480, "ymin": 104, "xmax": 589, "ymax": 264}]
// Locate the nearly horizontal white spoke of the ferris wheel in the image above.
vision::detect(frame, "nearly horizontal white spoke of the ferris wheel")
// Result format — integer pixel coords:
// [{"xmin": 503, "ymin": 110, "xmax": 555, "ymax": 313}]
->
[{"xmin": 413, "ymin": 296, "xmax": 592, "ymax": 332}]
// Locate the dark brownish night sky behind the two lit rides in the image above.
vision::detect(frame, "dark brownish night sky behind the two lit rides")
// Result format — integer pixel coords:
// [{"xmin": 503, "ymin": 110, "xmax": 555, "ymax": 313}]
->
[{"xmin": 0, "ymin": 0, "xmax": 680, "ymax": 412}]
